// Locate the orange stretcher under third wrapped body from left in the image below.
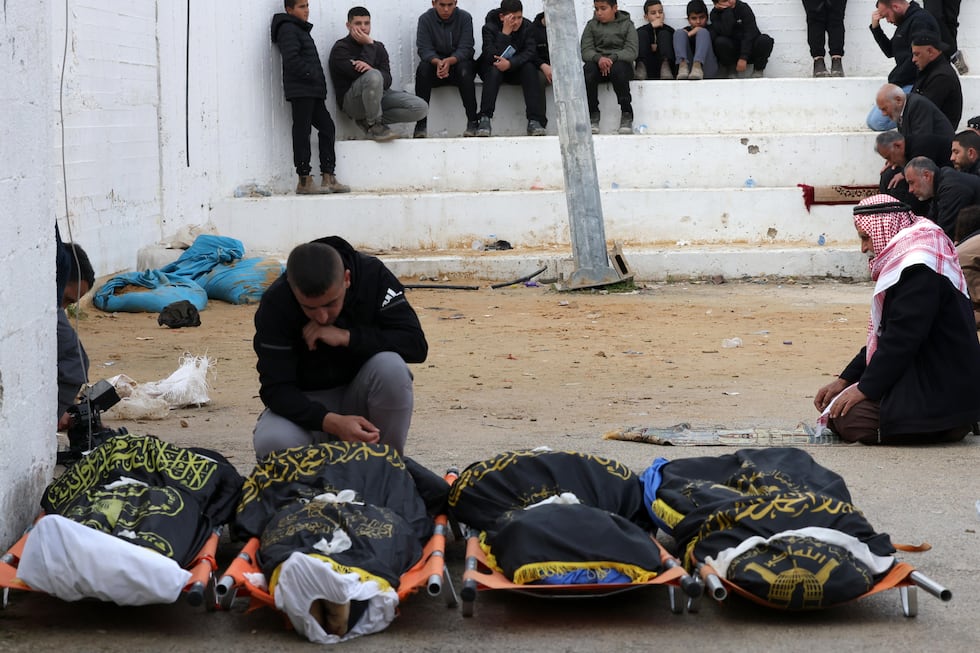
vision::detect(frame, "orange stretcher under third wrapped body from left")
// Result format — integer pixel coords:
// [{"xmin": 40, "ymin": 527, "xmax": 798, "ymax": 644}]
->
[{"xmin": 460, "ymin": 526, "xmax": 704, "ymax": 617}]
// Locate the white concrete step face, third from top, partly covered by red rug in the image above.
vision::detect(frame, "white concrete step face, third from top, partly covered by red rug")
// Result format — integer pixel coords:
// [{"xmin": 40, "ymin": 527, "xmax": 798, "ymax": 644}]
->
[{"xmin": 211, "ymin": 187, "xmax": 854, "ymax": 252}]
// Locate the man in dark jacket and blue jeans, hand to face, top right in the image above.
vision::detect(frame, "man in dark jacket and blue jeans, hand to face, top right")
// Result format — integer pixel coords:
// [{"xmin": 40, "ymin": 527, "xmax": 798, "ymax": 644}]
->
[{"xmin": 867, "ymin": 0, "xmax": 939, "ymax": 131}]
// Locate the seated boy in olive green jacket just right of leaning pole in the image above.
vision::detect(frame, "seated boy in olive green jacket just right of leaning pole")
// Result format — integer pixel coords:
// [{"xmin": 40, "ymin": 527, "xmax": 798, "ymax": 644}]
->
[{"xmin": 581, "ymin": 0, "xmax": 639, "ymax": 134}]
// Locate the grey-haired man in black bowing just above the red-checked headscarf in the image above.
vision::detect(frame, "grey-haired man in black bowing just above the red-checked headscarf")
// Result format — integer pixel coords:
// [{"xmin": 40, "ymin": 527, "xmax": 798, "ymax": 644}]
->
[{"xmin": 905, "ymin": 156, "xmax": 980, "ymax": 240}]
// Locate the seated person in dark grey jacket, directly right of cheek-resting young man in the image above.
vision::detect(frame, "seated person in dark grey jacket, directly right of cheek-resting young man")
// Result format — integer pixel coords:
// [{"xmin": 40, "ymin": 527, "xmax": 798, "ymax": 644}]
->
[{"xmin": 414, "ymin": 0, "xmax": 479, "ymax": 138}]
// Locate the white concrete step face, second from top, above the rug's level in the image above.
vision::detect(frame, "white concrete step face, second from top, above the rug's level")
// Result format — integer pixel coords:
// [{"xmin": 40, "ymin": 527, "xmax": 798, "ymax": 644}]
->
[{"xmin": 304, "ymin": 131, "xmax": 881, "ymax": 193}]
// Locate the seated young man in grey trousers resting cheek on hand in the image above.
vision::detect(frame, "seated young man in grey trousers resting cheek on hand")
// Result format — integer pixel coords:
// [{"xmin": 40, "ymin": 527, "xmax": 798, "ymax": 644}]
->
[{"xmin": 329, "ymin": 7, "xmax": 429, "ymax": 141}]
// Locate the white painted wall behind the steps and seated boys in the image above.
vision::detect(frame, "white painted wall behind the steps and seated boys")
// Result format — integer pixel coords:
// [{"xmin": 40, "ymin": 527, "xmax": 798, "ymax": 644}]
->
[{"xmin": 42, "ymin": 0, "xmax": 980, "ymax": 274}]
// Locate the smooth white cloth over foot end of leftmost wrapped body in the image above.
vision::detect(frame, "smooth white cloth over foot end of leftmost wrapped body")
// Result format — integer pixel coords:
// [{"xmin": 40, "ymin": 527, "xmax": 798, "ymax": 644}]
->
[{"xmin": 17, "ymin": 515, "xmax": 191, "ymax": 605}]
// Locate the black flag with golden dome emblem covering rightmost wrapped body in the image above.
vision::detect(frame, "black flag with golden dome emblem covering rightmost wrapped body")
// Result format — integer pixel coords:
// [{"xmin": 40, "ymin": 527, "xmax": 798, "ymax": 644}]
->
[{"xmin": 644, "ymin": 447, "xmax": 895, "ymax": 610}]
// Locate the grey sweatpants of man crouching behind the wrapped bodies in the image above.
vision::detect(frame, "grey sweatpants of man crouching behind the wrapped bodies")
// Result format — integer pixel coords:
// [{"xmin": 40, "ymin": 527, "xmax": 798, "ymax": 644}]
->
[{"xmin": 252, "ymin": 351, "xmax": 415, "ymax": 462}]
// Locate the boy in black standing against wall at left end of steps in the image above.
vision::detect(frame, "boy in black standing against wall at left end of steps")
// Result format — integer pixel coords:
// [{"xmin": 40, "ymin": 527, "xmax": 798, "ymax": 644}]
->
[{"xmin": 272, "ymin": 0, "xmax": 350, "ymax": 195}]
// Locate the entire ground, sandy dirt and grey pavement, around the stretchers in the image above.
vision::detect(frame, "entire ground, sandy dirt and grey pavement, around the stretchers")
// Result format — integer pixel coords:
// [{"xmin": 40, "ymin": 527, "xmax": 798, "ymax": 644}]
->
[{"xmin": 7, "ymin": 279, "xmax": 980, "ymax": 653}]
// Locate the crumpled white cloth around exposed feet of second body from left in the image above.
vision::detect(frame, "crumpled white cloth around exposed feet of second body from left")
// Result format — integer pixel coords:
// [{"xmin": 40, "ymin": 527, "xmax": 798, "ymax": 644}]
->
[{"xmin": 274, "ymin": 551, "xmax": 398, "ymax": 644}]
